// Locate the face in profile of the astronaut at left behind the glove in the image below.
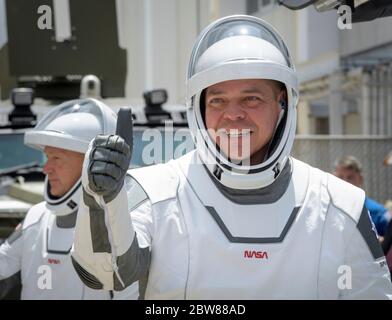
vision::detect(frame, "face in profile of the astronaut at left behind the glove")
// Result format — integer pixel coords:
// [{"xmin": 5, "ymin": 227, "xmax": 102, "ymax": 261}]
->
[{"xmin": 43, "ymin": 147, "xmax": 84, "ymax": 197}]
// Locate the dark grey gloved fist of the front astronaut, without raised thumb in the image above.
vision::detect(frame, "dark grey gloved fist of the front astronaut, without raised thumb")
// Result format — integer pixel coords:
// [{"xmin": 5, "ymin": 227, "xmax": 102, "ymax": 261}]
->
[{"xmin": 87, "ymin": 135, "xmax": 131, "ymax": 203}]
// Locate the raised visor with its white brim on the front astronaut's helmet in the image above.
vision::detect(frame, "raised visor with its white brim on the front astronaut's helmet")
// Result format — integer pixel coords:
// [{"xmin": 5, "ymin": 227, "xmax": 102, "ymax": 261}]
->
[{"xmin": 187, "ymin": 15, "xmax": 298, "ymax": 102}]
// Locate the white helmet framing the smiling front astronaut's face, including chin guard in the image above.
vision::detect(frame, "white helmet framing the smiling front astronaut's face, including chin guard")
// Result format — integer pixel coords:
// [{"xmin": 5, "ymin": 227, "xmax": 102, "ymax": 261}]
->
[{"xmin": 186, "ymin": 15, "xmax": 298, "ymax": 189}]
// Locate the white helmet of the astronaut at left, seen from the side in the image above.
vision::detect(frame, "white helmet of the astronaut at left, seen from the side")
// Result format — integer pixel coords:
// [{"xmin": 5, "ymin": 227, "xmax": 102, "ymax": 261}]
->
[{"xmin": 24, "ymin": 99, "xmax": 117, "ymax": 216}]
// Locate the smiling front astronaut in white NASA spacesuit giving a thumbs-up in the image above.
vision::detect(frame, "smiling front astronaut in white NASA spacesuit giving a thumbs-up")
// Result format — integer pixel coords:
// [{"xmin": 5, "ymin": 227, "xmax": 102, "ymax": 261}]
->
[{"xmin": 72, "ymin": 16, "xmax": 392, "ymax": 299}]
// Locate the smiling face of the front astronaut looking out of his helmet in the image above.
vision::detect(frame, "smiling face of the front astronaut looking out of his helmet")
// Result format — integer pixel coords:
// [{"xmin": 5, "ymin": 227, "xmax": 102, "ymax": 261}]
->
[{"xmin": 205, "ymin": 79, "xmax": 285, "ymax": 165}]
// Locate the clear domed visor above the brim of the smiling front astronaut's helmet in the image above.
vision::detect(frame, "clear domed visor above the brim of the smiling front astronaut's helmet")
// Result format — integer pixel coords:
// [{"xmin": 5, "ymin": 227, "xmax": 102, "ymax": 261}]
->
[{"xmin": 188, "ymin": 15, "xmax": 294, "ymax": 79}]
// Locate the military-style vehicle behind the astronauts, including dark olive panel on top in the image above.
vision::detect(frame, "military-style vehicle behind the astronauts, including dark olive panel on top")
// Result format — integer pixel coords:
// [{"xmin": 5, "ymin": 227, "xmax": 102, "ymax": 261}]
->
[{"xmin": 0, "ymin": 0, "xmax": 193, "ymax": 242}]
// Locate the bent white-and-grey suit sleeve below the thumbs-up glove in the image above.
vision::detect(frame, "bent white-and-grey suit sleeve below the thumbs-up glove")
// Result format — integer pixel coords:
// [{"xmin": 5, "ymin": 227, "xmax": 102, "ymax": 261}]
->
[{"xmin": 72, "ymin": 176, "xmax": 152, "ymax": 291}]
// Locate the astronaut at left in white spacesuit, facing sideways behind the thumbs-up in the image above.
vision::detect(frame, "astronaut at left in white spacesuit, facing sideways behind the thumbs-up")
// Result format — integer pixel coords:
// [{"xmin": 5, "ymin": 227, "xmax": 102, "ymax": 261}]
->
[{"xmin": 0, "ymin": 99, "xmax": 137, "ymax": 299}]
